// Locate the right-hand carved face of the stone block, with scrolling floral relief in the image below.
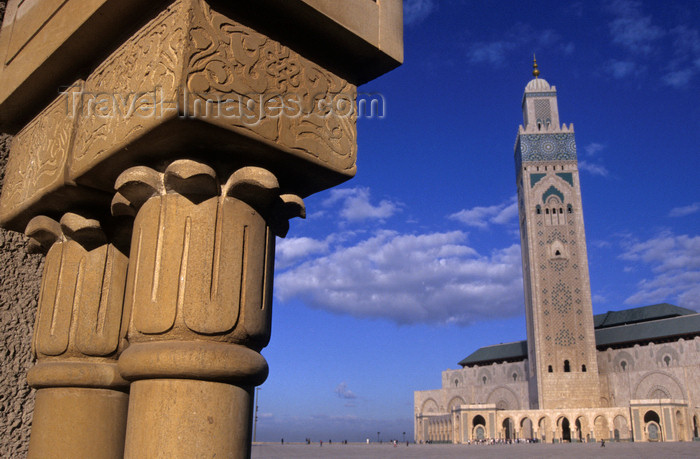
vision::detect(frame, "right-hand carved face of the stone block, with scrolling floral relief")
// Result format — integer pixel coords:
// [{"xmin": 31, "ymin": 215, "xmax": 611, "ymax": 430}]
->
[{"xmin": 186, "ymin": 1, "xmax": 357, "ymax": 170}]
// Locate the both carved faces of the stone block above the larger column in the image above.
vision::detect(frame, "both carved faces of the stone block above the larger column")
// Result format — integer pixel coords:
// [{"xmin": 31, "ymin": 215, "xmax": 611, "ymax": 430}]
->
[{"xmin": 70, "ymin": 0, "xmax": 357, "ymax": 181}]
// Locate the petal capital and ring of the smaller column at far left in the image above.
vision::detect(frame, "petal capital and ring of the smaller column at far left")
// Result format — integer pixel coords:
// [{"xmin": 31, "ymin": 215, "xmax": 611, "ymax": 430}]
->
[{"xmin": 26, "ymin": 213, "xmax": 128, "ymax": 387}]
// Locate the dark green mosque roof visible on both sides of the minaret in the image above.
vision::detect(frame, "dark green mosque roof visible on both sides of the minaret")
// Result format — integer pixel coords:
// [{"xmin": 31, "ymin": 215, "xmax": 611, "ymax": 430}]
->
[{"xmin": 459, "ymin": 303, "xmax": 700, "ymax": 367}]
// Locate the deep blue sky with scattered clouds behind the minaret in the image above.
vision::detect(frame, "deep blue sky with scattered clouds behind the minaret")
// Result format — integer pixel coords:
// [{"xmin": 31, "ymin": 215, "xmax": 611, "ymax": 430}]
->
[{"xmin": 257, "ymin": 0, "xmax": 700, "ymax": 441}]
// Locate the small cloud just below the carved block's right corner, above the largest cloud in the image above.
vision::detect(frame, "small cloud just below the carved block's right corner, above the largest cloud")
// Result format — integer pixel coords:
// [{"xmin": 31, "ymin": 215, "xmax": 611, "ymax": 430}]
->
[{"xmin": 322, "ymin": 188, "xmax": 400, "ymax": 222}]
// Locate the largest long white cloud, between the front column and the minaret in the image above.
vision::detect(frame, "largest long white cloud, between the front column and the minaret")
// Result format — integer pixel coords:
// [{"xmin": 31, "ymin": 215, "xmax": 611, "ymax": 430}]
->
[{"xmin": 275, "ymin": 231, "xmax": 523, "ymax": 324}]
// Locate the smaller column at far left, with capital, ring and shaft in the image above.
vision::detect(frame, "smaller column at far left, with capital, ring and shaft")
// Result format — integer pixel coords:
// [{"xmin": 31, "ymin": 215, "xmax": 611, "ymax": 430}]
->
[{"xmin": 26, "ymin": 213, "xmax": 128, "ymax": 459}]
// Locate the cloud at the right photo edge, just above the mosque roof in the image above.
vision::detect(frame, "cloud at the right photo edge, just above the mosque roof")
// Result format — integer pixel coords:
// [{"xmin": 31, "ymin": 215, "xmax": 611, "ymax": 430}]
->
[{"xmin": 621, "ymin": 232, "xmax": 700, "ymax": 310}]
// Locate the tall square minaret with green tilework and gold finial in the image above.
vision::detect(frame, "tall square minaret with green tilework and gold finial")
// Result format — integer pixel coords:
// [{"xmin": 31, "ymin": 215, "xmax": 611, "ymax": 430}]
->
[{"xmin": 515, "ymin": 60, "xmax": 600, "ymax": 409}]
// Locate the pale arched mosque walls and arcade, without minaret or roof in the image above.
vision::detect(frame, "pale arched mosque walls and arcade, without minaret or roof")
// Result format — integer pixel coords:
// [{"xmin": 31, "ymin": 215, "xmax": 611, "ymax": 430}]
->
[{"xmin": 414, "ymin": 337, "xmax": 700, "ymax": 443}]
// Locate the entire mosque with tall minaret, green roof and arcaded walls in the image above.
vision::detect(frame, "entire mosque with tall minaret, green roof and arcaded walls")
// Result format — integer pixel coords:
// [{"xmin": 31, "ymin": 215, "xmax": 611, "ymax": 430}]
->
[{"xmin": 414, "ymin": 62, "xmax": 700, "ymax": 443}]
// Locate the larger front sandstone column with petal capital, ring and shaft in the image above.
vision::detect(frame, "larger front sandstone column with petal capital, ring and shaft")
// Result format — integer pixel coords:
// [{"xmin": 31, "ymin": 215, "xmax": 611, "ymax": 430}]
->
[{"xmin": 112, "ymin": 160, "xmax": 305, "ymax": 458}]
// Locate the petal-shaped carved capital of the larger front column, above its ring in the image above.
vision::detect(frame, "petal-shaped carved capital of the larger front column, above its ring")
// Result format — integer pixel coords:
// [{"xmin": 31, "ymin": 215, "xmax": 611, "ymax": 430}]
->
[{"xmin": 112, "ymin": 160, "xmax": 305, "ymax": 362}]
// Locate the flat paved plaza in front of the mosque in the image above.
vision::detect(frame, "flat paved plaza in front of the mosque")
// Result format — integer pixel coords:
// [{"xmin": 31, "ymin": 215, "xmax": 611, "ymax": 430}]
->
[{"xmin": 252, "ymin": 442, "xmax": 700, "ymax": 459}]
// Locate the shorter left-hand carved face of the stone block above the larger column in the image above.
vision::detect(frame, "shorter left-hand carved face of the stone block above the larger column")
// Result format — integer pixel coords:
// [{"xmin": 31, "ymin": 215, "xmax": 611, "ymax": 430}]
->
[{"xmin": 69, "ymin": 1, "xmax": 187, "ymax": 177}]
